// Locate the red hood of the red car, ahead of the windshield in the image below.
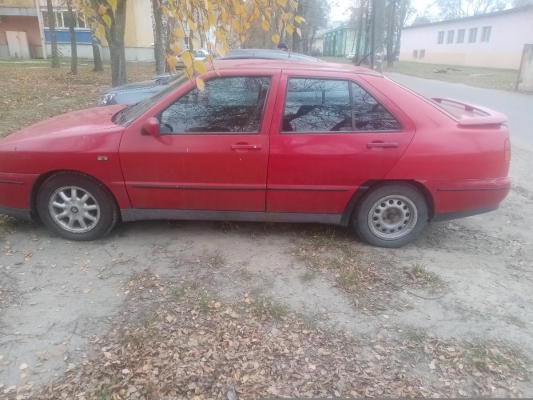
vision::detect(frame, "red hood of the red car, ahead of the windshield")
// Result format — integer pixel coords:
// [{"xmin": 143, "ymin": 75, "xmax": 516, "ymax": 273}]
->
[{"xmin": 0, "ymin": 104, "xmax": 124, "ymax": 147}]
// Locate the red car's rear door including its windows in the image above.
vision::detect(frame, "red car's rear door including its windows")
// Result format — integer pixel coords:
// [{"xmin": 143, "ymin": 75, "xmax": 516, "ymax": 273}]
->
[{"xmin": 267, "ymin": 70, "xmax": 415, "ymax": 215}]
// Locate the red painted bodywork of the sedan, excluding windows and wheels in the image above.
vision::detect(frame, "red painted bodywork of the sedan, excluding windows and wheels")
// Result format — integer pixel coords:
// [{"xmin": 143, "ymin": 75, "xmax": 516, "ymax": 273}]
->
[{"xmin": 0, "ymin": 60, "xmax": 510, "ymax": 222}]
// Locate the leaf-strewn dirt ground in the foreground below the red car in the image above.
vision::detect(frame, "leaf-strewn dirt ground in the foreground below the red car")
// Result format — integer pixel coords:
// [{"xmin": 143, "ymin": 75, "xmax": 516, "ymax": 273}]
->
[{"xmin": 0, "ymin": 61, "xmax": 533, "ymax": 400}]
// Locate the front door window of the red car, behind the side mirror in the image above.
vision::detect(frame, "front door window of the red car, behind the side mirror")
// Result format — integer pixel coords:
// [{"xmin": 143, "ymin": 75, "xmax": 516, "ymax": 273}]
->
[{"xmin": 160, "ymin": 76, "xmax": 271, "ymax": 134}]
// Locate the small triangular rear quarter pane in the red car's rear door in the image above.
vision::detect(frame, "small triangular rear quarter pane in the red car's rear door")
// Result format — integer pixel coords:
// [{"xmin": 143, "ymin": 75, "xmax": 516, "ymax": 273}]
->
[{"xmin": 351, "ymin": 82, "xmax": 402, "ymax": 131}]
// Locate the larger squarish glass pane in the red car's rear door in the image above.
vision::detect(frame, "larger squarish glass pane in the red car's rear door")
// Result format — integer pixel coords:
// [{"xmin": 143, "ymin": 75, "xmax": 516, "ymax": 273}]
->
[{"xmin": 282, "ymin": 78, "xmax": 352, "ymax": 132}]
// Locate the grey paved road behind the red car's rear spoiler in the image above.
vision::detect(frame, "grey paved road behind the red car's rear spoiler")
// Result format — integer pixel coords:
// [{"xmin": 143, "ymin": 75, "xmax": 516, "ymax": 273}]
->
[{"xmin": 386, "ymin": 73, "xmax": 533, "ymax": 150}]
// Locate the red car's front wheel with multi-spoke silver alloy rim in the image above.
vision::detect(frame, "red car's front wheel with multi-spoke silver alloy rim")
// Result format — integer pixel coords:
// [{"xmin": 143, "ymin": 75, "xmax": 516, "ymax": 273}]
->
[{"xmin": 37, "ymin": 172, "xmax": 118, "ymax": 241}]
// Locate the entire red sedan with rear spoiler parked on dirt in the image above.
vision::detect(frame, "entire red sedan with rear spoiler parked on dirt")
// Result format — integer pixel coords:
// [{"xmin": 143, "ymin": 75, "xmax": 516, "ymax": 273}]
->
[{"xmin": 0, "ymin": 60, "xmax": 510, "ymax": 247}]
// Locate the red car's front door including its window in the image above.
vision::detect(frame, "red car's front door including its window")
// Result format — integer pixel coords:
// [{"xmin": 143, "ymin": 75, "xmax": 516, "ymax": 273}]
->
[{"xmin": 120, "ymin": 70, "xmax": 280, "ymax": 211}]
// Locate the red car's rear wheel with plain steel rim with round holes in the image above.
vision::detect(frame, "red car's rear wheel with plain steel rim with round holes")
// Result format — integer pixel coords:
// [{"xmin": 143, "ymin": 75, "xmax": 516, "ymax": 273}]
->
[{"xmin": 352, "ymin": 183, "xmax": 428, "ymax": 248}]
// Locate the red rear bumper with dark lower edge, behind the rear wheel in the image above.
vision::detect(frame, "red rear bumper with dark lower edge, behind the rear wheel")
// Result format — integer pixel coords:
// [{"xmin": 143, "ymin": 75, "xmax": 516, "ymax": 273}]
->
[{"xmin": 428, "ymin": 178, "xmax": 511, "ymax": 217}]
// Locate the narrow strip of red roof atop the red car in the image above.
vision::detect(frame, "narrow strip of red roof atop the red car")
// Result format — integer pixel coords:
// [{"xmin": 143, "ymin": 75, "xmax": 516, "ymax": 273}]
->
[{"xmin": 210, "ymin": 59, "xmax": 383, "ymax": 76}]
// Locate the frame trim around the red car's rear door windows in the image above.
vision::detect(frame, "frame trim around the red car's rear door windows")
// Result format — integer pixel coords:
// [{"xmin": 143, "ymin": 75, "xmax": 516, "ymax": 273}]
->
[{"xmin": 278, "ymin": 75, "xmax": 405, "ymax": 135}]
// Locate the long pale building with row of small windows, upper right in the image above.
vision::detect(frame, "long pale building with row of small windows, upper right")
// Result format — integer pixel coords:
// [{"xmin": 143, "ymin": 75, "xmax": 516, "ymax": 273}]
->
[{"xmin": 400, "ymin": 5, "xmax": 533, "ymax": 69}]
